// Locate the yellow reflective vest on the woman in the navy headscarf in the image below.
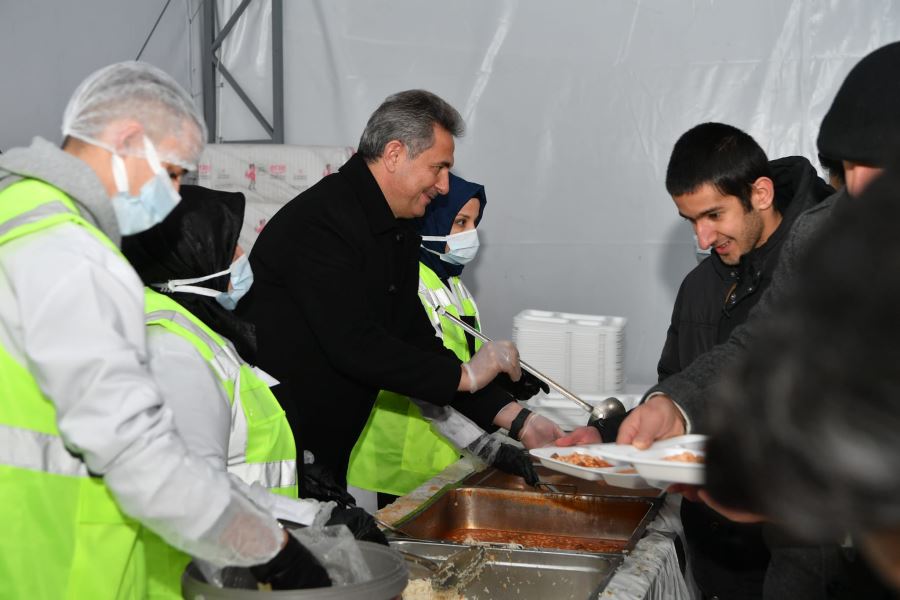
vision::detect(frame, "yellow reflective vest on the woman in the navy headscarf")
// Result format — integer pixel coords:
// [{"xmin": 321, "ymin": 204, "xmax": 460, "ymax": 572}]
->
[{"xmin": 347, "ymin": 263, "xmax": 481, "ymax": 495}]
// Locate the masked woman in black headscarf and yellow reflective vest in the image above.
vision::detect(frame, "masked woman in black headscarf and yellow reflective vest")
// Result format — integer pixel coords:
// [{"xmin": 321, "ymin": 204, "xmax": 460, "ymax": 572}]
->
[{"xmin": 122, "ymin": 185, "xmax": 352, "ymax": 598}]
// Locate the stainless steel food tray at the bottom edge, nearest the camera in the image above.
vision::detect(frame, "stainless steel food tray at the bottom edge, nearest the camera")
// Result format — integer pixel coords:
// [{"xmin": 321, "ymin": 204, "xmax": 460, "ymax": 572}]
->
[{"xmin": 391, "ymin": 539, "xmax": 623, "ymax": 600}]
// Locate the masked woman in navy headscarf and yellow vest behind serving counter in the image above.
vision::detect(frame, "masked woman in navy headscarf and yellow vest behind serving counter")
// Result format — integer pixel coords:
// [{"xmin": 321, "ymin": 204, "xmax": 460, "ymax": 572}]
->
[{"xmin": 347, "ymin": 173, "xmax": 555, "ymax": 504}]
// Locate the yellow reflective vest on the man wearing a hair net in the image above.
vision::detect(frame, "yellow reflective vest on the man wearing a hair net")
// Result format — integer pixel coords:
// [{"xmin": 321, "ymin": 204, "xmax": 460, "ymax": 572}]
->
[{"xmin": 0, "ymin": 179, "xmax": 147, "ymax": 598}]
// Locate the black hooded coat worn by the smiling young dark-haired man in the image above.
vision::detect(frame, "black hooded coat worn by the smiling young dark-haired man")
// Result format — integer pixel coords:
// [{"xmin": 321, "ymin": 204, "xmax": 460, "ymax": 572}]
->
[{"xmin": 657, "ymin": 157, "xmax": 833, "ymax": 599}]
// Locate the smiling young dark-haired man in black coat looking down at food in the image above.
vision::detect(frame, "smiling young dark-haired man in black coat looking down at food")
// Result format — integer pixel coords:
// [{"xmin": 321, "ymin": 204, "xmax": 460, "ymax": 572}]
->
[{"xmin": 657, "ymin": 123, "xmax": 836, "ymax": 600}]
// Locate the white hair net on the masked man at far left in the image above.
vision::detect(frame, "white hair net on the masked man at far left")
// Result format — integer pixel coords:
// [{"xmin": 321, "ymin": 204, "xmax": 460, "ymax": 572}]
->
[{"xmin": 62, "ymin": 61, "xmax": 206, "ymax": 169}]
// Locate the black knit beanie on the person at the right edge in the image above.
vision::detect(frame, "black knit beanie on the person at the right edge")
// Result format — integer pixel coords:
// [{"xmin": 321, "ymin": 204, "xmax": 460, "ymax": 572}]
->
[{"xmin": 817, "ymin": 42, "xmax": 900, "ymax": 167}]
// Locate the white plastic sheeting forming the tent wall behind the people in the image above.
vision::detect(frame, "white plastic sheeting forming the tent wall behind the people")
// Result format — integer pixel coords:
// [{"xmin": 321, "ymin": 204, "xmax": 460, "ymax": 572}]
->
[{"xmin": 220, "ymin": 0, "xmax": 900, "ymax": 383}]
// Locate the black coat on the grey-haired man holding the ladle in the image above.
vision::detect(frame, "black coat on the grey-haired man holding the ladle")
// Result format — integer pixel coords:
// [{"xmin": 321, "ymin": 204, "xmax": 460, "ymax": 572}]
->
[{"xmin": 239, "ymin": 156, "xmax": 511, "ymax": 481}]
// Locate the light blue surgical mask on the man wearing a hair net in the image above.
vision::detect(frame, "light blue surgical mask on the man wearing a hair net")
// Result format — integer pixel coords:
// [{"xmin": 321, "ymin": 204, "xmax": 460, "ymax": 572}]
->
[{"xmin": 108, "ymin": 136, "xmax": 181, "ymax": 235}]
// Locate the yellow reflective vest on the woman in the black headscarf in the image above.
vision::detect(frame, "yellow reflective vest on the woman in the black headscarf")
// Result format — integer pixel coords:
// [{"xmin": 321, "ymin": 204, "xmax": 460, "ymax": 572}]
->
[{"xmin": 145, "ymin": 288, "xmax": 297, "ymax": 498}]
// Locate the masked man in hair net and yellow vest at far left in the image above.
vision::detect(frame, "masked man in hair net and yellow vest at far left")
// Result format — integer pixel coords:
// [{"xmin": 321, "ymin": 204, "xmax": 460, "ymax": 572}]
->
[{"xmin": 0, "ymin": 62, "xmax": 326, "ymax": 598}]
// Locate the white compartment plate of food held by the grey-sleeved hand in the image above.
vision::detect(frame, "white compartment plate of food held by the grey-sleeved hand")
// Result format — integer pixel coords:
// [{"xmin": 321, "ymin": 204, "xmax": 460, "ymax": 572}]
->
[{"xmin": 592, "ymin": 435, "xmax": 706, "ymax": 489}]
